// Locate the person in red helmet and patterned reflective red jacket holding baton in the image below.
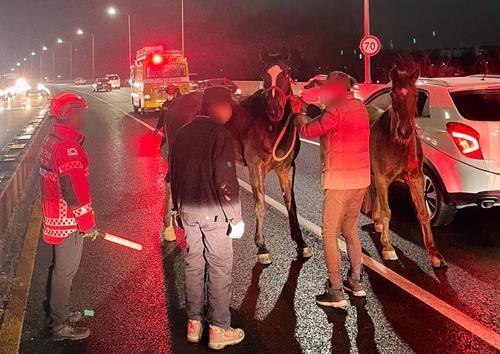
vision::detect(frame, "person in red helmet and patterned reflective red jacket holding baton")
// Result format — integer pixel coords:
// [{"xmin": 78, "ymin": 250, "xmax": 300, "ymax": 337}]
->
[{"xmin": 40, "ymin": 93, "xmax": 99, "ymax": 341}]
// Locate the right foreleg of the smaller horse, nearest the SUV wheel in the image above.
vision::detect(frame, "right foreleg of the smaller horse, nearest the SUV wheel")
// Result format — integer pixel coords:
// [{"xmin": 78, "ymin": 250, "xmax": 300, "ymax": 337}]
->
[{"xmin": 406, "ymin": 173, "xmax": 446, "ymax": 268}]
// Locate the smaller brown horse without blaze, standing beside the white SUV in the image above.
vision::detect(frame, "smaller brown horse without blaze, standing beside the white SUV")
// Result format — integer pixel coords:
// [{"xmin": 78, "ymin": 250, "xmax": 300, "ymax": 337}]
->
[{"xmin": 369, "ymin": 68, "xmax": 446, "ymax": 267}]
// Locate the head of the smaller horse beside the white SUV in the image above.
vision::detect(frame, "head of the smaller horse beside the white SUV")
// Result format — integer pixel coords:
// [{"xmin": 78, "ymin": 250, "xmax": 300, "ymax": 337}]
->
[{"xmin": 389, "ymin": 68, "xmax": 420, "ymax": 141}]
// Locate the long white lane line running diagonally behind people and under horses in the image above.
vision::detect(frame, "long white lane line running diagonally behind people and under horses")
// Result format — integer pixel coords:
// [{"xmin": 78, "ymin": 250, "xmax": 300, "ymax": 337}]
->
[{"xmin": 72, "ymin": 90, "xmax": 500, "ymax": 350}]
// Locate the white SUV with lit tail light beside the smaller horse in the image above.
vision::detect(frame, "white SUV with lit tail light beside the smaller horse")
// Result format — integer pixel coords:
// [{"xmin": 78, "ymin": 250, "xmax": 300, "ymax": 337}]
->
[{"xmin": 365, "ymin": 75, "xmax": 500, "ymax": 226}]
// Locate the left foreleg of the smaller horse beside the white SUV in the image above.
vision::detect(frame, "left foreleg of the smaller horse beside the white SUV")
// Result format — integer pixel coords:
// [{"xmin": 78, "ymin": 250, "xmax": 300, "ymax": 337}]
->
[{"xmin": 375, "ymin": 177, "xmax": 398, "ymax": 261}]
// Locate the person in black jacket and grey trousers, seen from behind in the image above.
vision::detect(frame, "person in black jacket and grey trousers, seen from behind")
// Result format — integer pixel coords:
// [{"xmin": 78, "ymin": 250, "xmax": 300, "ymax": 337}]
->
[{"xmin": 170, "ymin": 86, "xmax": 245, "ymax": 349}]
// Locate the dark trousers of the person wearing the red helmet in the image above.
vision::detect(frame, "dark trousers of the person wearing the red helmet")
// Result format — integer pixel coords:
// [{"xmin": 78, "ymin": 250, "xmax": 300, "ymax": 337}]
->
[{"xmin": 47, "ymin": 233, "xmax": 83, "ymax": 328}]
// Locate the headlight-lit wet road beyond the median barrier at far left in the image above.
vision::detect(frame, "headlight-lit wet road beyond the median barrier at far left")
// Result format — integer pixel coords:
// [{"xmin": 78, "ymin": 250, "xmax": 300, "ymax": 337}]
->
[{"xmin": 0, "ymin": 95, "xmax": 46, "ymax": 149}]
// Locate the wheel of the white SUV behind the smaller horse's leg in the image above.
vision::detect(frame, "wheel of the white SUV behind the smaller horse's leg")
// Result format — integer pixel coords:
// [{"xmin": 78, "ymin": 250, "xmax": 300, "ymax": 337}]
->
[{"xmin": 424, "ymin": 167, "xmax": 457, "ymax": 226}]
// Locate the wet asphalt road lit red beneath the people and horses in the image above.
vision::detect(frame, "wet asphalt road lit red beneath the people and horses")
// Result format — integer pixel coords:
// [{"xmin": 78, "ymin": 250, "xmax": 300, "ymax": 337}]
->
[{"xmin": 21, "ymin": 87, "xmax": 500, "ymax": 353}]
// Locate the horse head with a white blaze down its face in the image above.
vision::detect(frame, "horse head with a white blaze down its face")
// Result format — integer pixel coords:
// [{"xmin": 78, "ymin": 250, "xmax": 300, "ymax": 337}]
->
[{"xmin": 260, "ymin": 48, "xmax": 292, "ymax": 122}]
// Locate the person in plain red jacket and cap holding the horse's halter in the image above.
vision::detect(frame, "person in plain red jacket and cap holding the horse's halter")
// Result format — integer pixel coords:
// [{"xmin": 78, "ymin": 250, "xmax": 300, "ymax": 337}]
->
[{"xmin": 292, "ymin": 71, "xmax": 370, "ymax": 307}]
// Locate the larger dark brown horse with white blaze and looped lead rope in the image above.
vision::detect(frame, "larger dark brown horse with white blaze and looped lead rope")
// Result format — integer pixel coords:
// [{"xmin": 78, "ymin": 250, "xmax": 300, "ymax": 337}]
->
[{"xmin": 164, "ymin": 48, "xmax": 313, "ymax": 265}]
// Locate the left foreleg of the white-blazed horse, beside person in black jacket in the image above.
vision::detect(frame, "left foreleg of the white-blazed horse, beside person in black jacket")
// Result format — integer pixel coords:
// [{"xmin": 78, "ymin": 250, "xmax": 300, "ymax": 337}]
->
[{"xmin": 248, "ymin": 164, "xmax": 272, "ymax": 264}]
